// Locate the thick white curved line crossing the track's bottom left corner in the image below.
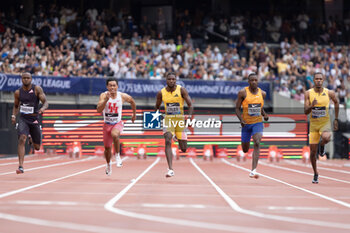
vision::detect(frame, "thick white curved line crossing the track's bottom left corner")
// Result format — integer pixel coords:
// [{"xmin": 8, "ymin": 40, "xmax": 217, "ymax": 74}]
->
[{"xmin": 0, "ymin": 213, "xmax": 157, "ymax": 233}]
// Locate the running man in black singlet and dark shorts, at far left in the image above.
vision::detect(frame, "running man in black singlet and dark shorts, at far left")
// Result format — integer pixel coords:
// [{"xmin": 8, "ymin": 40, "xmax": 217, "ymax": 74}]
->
[{"xmin": 11, "ymin": 73, "xmax": 49, "ymax": 174}]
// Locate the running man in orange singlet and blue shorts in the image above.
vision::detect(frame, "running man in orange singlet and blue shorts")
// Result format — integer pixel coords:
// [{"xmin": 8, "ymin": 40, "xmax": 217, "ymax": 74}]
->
[{"xmin": 236, "ymin": 73, "xmax": 269, "ymax": 179}]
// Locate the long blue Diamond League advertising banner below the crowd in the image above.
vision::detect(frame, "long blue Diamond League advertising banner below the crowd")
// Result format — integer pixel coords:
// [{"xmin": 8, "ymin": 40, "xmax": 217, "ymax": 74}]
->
[{"xmin": 0, "ymin": 74, "xmax": 271, "ymax": 100}]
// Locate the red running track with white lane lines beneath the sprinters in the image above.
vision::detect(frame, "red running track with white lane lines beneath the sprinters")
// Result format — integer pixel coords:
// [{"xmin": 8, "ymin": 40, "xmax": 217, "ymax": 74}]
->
[{"xmin": 0, "ymin": 156, "xmax": 350, "ymax": 233}]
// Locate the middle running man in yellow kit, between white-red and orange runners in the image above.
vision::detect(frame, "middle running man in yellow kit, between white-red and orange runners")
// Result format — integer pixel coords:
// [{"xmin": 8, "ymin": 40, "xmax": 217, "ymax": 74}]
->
[{"xmin": 155, "ymin": 72, "xmax": 193, "ymax": 177}]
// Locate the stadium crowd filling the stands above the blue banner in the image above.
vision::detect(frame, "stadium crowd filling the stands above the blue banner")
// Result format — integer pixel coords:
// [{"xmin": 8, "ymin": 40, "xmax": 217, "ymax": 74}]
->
[{"xmin": 0, "ymin": 4, "xmax": 350, "ymax": 103}]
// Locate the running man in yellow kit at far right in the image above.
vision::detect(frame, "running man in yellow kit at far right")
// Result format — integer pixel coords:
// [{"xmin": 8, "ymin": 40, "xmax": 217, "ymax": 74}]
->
[{"xmin": 304, "ymin": 73, "xmax": 339, "ymax": 184}]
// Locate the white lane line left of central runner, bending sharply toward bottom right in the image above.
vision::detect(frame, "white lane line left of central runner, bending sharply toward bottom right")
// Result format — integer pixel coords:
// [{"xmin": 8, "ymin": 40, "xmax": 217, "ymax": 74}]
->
[{"xmin": 104, "ymin": 157, "xmax": 304, "ymax": 233}]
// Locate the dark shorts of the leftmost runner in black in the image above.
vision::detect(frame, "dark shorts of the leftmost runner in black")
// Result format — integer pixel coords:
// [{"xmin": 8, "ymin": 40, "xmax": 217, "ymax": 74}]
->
[{"xmin": 17, "ymin": 116, "xmax": 41, "ymax": 145}]
